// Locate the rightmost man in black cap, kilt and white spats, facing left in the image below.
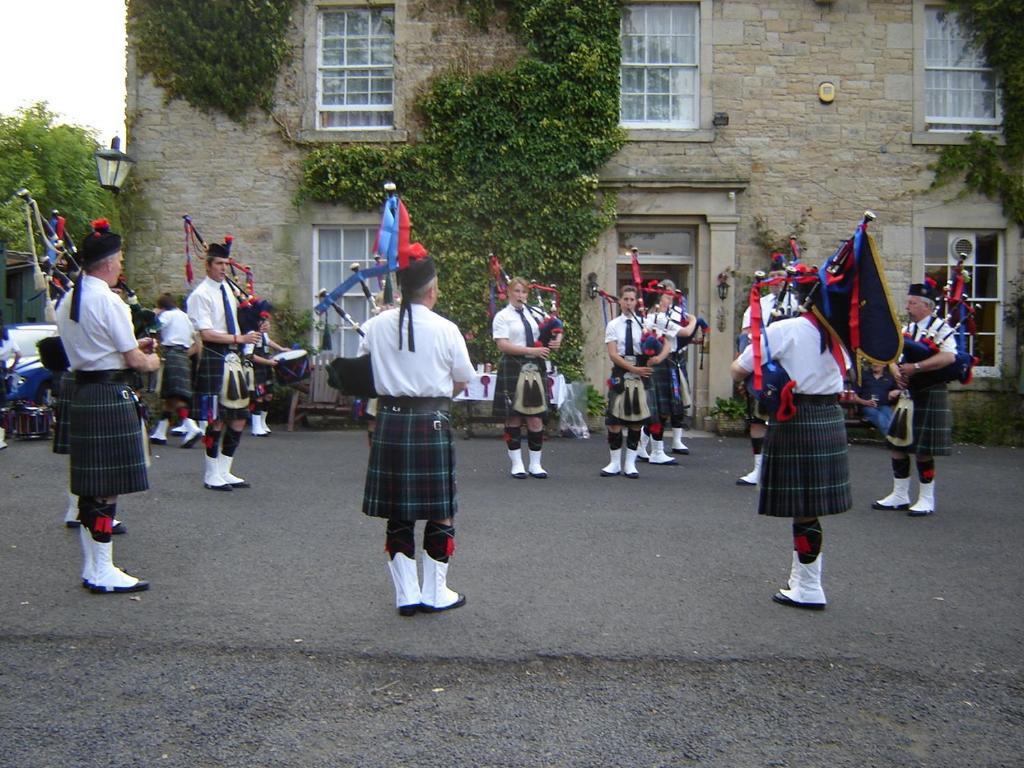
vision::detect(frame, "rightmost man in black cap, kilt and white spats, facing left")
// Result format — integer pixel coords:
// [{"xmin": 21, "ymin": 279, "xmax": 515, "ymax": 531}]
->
[{"xmin": 871, "ymin": 279, "xmax": 957, "ymax": 517}]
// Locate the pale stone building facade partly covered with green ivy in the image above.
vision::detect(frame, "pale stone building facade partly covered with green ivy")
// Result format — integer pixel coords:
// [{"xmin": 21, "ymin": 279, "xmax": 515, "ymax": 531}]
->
[{"xmin": 128, "ymin": 0, "xmax": 1021, "ymax": 423}]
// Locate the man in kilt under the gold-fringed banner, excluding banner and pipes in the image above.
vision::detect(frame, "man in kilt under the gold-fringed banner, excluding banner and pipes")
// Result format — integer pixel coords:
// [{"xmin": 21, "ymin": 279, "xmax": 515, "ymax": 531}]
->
[{"xmin": 730, "ymin": 264, "xmax": 852, "ymax": 610}]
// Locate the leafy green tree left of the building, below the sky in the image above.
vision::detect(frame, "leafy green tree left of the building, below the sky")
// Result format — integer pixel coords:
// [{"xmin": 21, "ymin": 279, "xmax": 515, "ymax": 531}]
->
[{"xmin": 0, "ymin": 103, "xmax": 119, "ymax": 254}]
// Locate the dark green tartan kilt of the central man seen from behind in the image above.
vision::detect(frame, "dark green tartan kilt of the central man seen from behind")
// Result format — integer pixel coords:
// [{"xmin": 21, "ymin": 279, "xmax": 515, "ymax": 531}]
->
[{"xmin": 362, "ymin": 407, "xmax": 459, "ymax": 520}]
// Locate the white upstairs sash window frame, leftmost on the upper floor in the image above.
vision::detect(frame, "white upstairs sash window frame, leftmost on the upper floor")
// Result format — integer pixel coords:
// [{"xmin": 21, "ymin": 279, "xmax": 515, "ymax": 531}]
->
[{"xmin": 316, "ymin": 6, "xmax": 395, "ymax": 132}]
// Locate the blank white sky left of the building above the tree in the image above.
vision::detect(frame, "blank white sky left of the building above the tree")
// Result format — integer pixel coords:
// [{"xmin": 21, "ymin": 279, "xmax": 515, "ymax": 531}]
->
[{"xmin": 0, "ymin": 0, "xmax": 131, "ymax": 144}]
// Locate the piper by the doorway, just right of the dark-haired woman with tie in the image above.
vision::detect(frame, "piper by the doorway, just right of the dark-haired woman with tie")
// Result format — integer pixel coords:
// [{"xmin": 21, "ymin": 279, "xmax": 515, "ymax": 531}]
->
[{"xmin": 641, "ymin": 280, "xmax": 697, "ymax": 464}]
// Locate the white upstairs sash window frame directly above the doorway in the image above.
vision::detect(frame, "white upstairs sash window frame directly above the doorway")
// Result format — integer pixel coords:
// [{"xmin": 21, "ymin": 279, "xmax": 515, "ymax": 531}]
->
[{"xmin": 620, "ymin": 2, "xmax": 705, "ymax": 131}]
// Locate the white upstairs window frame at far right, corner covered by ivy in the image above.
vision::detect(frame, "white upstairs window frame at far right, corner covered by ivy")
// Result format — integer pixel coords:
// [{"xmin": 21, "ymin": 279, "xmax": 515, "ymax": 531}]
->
[{"xmin": 920, "ymin": 5, "xmax": 1002, "ymax": 133}]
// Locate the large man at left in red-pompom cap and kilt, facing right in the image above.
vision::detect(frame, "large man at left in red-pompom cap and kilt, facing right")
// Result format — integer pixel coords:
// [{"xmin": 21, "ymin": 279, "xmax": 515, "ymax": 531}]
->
[{"xmin": 54, "ymin": 219, "xmax": 160, "ymax": 593}]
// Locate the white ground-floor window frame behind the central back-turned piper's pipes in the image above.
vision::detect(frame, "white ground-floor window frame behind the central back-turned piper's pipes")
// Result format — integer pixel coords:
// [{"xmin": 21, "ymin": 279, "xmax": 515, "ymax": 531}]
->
[{"xmin": 310, "ymin": 225, "xmax": 377, "ymax": 357}]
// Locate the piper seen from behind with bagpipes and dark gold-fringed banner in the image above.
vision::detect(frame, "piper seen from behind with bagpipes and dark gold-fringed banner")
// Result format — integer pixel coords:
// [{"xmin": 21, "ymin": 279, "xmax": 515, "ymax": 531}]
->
[{"xmin": 731, "ymin": 211, "xmax": 902, "ymax": 610}]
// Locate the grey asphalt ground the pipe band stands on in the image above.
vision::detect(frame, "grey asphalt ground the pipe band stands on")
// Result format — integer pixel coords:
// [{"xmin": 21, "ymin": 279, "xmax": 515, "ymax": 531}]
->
[{"xmin": 0, "ymin": 427, "xmax": 1024, "ymax": 768}]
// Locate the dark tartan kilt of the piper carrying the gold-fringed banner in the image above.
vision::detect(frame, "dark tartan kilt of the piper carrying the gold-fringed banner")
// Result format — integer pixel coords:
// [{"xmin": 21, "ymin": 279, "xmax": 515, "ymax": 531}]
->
[{"xmin": 758, "ymin": 395, "xmax": 853, "ymax": 517}]
